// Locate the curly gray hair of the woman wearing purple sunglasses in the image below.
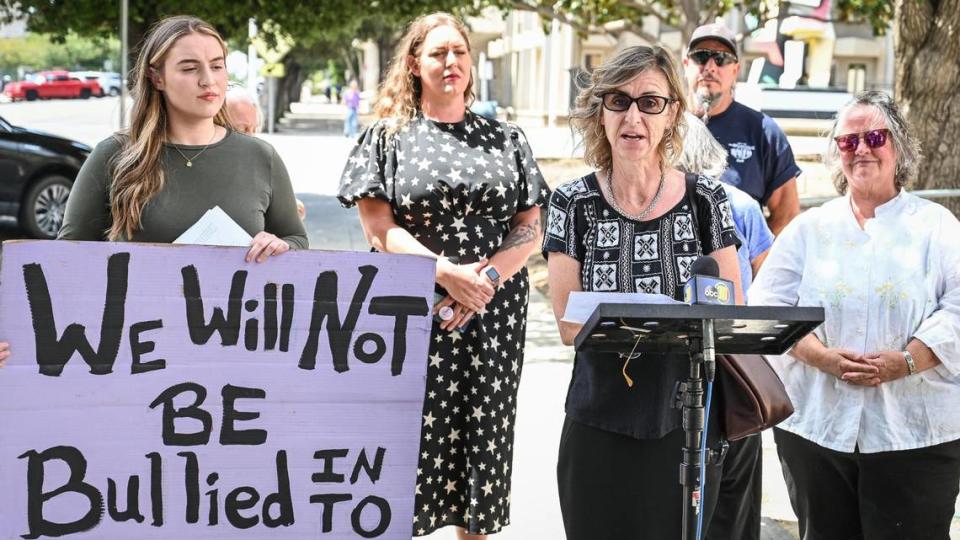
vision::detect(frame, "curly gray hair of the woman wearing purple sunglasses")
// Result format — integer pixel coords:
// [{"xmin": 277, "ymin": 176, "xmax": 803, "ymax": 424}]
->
[{"xmin": 823, "ymin": 90, "xmax": 923, "ymax": 195}]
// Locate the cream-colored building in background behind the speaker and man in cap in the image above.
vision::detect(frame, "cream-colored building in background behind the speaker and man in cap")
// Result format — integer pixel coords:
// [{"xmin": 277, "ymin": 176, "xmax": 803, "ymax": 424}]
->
[{"xmin": 471, "ymin": 0, "xmax": 894, "ymax": 126}]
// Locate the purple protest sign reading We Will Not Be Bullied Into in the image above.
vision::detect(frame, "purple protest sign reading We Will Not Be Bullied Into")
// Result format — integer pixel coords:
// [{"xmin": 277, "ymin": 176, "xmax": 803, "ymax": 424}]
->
[{"xmin": 0, "ymin": 242, "xmax": 434, "ymax": 539}]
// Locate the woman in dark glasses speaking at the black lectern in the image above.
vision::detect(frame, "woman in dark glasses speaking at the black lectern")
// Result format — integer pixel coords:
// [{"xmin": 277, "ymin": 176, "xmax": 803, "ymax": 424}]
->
[{"xmin": 543, "ymin": 47, "xmax": 742, "ymax": 540}]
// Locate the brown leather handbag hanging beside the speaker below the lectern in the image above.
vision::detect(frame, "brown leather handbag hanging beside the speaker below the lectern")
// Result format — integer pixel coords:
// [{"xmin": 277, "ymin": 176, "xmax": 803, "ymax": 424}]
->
[{"xmin": 717, "ymin": 354, "xmax": 793, "ymax": 441}]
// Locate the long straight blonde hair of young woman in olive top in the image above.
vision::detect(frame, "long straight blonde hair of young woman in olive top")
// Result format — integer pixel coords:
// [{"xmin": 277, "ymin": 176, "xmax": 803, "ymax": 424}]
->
[{"xmin": 107, "ymin": 15, "xmax": 230, "ymax": 240}]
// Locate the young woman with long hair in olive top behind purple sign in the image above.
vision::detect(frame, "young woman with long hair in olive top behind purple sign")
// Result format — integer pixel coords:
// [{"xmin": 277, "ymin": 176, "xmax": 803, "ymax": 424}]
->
[{"xmin": 59, "ymin": 16, "xmax": 307, "ymax": 256}]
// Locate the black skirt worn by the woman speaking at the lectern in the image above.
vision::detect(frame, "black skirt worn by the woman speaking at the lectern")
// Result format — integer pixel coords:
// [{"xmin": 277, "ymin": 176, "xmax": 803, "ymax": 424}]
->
[{"xmin": 557, "ymin": 417, "xmax": 720, "ymax": 540}]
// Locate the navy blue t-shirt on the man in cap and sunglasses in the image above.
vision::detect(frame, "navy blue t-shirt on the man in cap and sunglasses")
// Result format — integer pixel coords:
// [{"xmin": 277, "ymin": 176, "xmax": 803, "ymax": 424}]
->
[{"xmin": 707, "ymin": 101, "xmax": 801, "ymax": 205}]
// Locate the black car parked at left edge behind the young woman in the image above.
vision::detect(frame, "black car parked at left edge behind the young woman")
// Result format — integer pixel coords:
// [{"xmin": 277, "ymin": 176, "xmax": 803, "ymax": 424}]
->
[{"xmin": 0, "ymin": 118, "xmax": 93, "ymax": 238}]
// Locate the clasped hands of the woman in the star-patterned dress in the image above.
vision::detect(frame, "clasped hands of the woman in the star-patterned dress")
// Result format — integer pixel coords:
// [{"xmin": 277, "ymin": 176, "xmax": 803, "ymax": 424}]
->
[{"xmin": 433, "ymin": 258, "xmax": 496, "ymax": 331}]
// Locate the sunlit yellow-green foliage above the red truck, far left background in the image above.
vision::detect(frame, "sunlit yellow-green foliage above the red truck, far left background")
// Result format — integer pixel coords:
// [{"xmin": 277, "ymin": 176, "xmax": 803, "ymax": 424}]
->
[{"xmin": 0, "ymin": 34, "xmax": 120, "ymax": 75}]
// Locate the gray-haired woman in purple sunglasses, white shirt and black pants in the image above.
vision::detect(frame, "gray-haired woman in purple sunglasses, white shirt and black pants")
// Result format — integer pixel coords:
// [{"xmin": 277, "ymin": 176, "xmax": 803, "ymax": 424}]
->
[{"xmin": 749, "ymin": 92, "xmax": 960, "ymax": 540}]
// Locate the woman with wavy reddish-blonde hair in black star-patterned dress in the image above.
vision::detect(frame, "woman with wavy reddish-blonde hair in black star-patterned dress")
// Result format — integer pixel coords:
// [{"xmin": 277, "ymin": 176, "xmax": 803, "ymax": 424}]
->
[{"xmin": 340, "ymin": 13, "xmax": 549, "ymax": 538}]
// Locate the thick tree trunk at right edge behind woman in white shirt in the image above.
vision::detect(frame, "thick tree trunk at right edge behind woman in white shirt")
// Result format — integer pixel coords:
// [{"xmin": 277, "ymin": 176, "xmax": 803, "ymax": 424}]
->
[{"xmin": 894, "ymin": 0, "xmax": 960, "ymax": 216}]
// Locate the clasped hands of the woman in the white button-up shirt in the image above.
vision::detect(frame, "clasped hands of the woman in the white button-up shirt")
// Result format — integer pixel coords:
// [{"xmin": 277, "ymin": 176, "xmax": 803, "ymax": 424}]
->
[{"xmin": 817, "ymin": 349, "xmax": 910, "ymax": 386}]
